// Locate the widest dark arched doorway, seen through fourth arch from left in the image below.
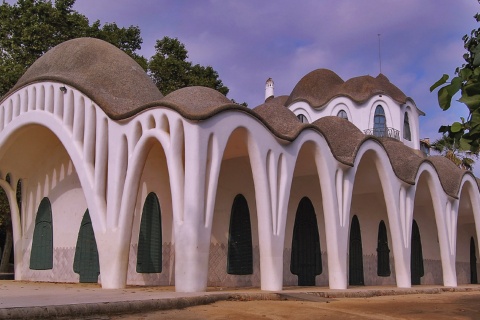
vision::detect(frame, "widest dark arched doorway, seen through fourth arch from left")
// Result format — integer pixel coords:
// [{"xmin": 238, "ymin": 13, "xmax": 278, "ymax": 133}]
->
[{"xmin": 290, "ymin": 197, "xmax": 322, "ymax": 286}]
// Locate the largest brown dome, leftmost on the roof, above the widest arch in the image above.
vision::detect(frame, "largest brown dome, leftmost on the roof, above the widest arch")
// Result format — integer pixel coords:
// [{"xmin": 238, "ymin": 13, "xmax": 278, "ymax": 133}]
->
[{"xmin": 13, "ymin": 38, "xmax": 163, "ymax": 119}]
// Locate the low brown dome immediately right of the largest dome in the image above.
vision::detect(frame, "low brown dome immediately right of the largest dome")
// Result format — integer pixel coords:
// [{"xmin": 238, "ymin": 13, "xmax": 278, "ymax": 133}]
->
[{"xmin": 156, "ymin": 86, "xmax": 238, "ymax": 120}]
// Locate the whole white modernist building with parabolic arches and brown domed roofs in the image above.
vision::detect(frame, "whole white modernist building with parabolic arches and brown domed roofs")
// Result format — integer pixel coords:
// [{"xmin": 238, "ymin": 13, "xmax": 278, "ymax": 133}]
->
[{"xmin": 0, "ymin": 38, "xmax": 480, "ymax": 291}]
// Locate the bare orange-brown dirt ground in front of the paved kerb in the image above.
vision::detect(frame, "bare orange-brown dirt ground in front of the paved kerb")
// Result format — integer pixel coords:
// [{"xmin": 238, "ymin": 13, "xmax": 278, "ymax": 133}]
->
[{"xmin": 109, "ymin": 292, "xmax": 480, "ymax": 320}]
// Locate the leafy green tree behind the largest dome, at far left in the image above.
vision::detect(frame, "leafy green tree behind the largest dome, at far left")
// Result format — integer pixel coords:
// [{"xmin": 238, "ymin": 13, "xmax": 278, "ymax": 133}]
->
[{"xmin": 0, "ymin": 0, "xmax": 147, "ymax": 97}]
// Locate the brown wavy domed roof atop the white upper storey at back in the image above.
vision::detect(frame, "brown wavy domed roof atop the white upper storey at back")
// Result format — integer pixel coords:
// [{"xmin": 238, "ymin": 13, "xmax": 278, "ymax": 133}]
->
[{"xmin": 285, "ymin": 69, "xmax": 407, "ymax": 108}]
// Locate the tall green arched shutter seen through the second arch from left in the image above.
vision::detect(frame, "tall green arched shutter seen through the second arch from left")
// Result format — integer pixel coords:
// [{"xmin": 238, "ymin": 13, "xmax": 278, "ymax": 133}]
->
[{"xmin": 136, "ymin": 192, "xmax": 162, "ymax": 273}]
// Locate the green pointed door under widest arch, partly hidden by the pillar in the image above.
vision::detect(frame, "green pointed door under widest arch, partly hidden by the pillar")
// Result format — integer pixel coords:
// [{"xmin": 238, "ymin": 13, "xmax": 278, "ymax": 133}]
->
[{"xmin": 73, "ymin": 209, "xmax": 100, "ymax": 283}]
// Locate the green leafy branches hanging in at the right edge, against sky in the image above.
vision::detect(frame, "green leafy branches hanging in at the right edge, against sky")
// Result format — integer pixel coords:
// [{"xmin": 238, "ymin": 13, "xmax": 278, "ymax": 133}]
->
[{"xmin": 430, "ymin": 1, "xmax": 480, "ymax": 153}]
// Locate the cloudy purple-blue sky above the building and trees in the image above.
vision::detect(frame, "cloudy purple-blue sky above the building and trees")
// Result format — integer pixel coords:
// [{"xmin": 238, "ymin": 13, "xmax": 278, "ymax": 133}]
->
[{"xmin": 8, "ymin": 0, "xmax": 480, "ymax": 152}]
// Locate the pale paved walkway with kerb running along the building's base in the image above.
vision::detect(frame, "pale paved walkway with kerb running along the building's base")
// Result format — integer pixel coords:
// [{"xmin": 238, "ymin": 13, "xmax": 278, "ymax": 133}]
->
[{"xmin": 0, "ymin": 280, "xmax": 480, "ymax": 319}]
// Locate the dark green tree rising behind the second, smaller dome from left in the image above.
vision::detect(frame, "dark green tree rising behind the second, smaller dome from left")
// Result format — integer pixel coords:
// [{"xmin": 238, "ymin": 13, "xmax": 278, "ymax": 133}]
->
[{"xmin": 148, "ymin": 37, "xmax": 229, "ymax": 95}]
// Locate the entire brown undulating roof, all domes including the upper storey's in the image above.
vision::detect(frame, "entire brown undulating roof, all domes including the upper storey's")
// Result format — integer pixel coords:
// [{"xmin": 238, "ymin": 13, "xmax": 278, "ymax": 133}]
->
[{"xmin": 4, "ymin": 38, "xmax": 476, "ymax": 197}]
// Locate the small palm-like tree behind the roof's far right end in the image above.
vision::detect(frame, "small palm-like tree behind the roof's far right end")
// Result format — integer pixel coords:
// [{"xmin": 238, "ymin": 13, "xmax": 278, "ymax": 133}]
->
[{"xmin": 431, "ymin": 134, "xmax": 478, "ymax": 171}]
